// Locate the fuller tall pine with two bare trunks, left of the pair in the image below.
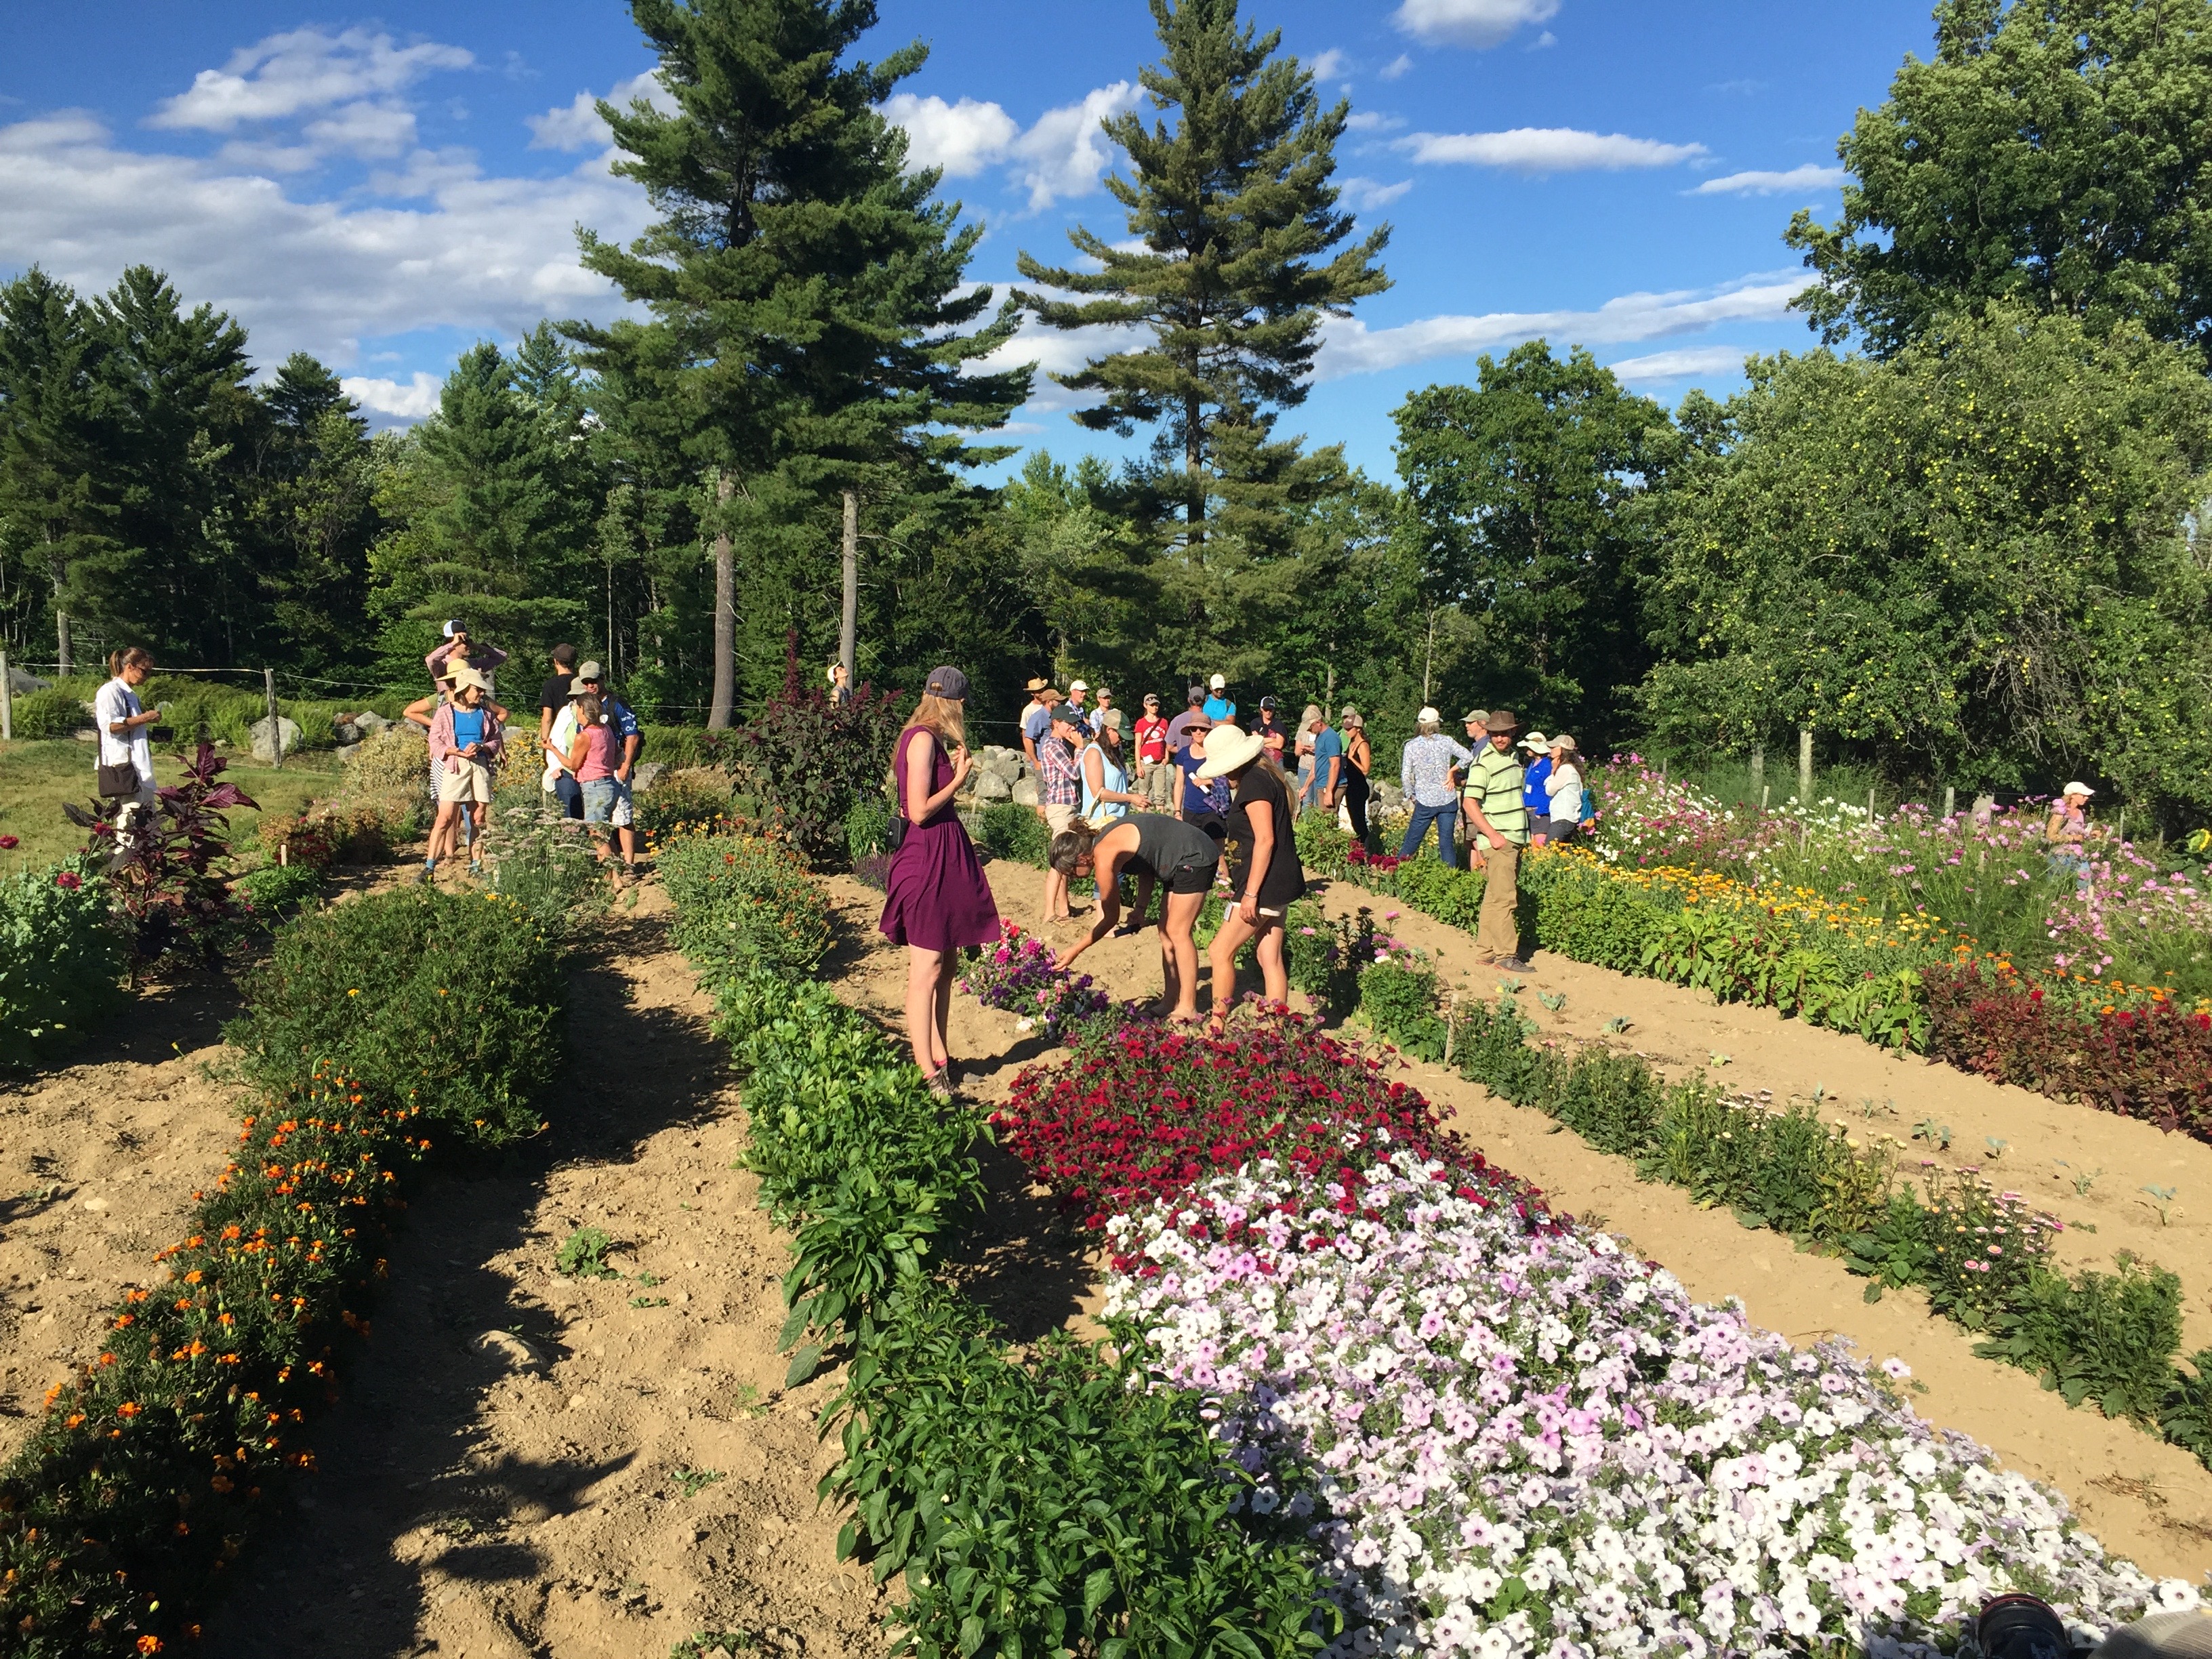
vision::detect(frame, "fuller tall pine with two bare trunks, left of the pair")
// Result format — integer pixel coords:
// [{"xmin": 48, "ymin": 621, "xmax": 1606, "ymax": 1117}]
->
[{"xmin": 564, "ymin": 0, "xmax": 1029, "ymax": 726}]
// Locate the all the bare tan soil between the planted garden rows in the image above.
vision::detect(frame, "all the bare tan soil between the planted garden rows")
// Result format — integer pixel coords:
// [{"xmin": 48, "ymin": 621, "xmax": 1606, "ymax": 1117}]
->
[{"xmin": 0, "ymin": 865, "xmax": 2212, "ymax": 1659}]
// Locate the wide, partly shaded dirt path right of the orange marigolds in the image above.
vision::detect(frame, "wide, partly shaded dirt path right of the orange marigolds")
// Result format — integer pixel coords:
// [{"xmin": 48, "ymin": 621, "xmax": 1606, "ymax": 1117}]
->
[{"xmin": 192, "ymin": 889, "xmax": 882, "ymax": 1659}]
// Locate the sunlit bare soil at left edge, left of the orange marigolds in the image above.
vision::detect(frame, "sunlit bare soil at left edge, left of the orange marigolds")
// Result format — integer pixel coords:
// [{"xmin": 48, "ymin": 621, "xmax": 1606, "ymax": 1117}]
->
[{"xmin": 0, "ymin": 980, "xmax": 239, "ymax": 1458}]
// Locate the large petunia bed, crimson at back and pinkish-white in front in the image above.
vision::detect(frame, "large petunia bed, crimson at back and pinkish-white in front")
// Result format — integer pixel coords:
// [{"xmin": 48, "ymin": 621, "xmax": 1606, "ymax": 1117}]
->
[{"xmin": 998, "ymin": 1024, "xmax": 2196, "ymax": 1659}]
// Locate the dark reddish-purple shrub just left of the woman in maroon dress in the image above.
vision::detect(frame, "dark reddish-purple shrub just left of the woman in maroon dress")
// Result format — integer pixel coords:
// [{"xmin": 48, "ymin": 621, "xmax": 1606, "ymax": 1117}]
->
[{"xmin": 730, "ymin": 686, "xmax": 905, "ymax": 865}]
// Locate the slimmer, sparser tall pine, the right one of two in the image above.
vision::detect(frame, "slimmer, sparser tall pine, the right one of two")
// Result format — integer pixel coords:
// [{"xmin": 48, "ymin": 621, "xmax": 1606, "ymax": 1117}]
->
[{"xmin": 1020, "ymin": 0, "xmax": 1389, "ymax": 672}]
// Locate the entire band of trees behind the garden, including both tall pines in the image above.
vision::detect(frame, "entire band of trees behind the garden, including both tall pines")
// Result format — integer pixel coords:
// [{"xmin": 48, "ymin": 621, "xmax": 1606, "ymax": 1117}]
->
[{"xmin": 0, "ymin": 0, "xmax": 2212, "ymax": 821}]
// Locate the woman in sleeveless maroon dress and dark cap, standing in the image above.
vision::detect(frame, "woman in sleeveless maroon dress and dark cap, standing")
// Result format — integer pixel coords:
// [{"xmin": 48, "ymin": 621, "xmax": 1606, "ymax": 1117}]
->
[{"xmin": 882, "ymin": 668, "xmax": 998, "ymax": 1097}]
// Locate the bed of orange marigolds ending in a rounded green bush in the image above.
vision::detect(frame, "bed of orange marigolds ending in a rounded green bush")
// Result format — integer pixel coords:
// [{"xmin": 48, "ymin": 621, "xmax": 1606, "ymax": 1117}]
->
[{"xmin": 0, "ymin": 891, "xmax": 562, "ymax": 1659}]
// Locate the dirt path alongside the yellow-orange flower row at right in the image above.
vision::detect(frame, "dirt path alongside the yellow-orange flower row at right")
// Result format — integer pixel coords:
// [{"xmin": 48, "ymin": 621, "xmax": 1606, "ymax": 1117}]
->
[{"xmin": 1323, "ymin": 882, "xmax": 2212, "ymax": 1351}]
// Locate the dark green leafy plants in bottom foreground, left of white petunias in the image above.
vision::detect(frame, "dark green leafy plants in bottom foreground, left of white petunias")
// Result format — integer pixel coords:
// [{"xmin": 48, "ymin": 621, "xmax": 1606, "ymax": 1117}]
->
[{"xmin": 823, "ymin": 1285, "xmax": 1340, "ymax": 1659}]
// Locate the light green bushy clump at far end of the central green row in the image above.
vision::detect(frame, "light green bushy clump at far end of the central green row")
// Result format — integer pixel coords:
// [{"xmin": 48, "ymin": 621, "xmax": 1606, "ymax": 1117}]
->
[{"xmin": 659, "ymin": 836, "xmax": 832, "ymax": 982}]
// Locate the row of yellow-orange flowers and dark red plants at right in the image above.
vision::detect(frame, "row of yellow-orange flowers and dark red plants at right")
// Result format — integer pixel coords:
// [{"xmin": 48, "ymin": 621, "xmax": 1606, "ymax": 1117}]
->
[{"xmin": 1298, "ymin": 821, "xmax": 2212, "ymax": 1141}]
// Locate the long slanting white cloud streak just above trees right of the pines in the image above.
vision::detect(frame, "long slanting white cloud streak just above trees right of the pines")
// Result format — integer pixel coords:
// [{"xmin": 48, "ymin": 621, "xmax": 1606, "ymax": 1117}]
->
[{"xmin": 1316, "ymin": 272, "xmax": 1807, "ymax": 380}]
